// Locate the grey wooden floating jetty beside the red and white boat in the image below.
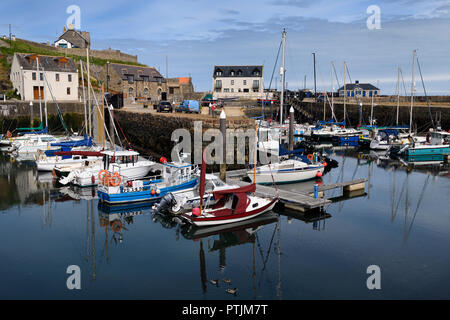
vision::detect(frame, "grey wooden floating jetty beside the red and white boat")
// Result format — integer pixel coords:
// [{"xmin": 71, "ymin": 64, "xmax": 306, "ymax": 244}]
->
[{"xmin": 223, "ymin": 169, "xmax": 367, "ymax": 212}]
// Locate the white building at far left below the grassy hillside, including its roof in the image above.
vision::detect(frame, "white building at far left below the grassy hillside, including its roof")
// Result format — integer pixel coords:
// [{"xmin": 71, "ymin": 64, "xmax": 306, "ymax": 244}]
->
[{"xmin": 10, "ymin": 53, "xmax": 78, "ymax": 101}]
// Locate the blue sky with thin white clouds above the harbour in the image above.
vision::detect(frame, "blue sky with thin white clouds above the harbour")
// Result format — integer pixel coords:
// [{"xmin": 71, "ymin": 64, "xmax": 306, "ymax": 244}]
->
[{"xmin": 0, "ymin": 0, "xmax": 450, "ymax": 95}]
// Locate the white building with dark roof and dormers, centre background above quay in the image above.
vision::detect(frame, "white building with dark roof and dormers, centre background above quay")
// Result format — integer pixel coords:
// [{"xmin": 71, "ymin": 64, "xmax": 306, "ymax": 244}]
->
[{"xmin": 213, "ymin": 66, "xmax": 264, "ymax": 99}]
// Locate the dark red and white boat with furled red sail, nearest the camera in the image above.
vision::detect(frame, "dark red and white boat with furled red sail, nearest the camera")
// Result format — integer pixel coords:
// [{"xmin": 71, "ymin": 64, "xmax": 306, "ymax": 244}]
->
[{"xmin": 181, "ymin": 152, "xmax": 278, "ymax": 227}]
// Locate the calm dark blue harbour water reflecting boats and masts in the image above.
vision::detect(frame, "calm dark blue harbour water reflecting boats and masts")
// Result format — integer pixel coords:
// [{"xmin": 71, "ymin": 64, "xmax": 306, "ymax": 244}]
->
[{"xmin": 0, "ymin": 150, "xmax": 450, "ymax": 300}]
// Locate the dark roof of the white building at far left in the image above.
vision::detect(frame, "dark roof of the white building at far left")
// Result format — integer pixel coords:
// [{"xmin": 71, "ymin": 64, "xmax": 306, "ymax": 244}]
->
[{"xmin": 15, "ymin": 53, "xmax": 77, "ymax": 72}]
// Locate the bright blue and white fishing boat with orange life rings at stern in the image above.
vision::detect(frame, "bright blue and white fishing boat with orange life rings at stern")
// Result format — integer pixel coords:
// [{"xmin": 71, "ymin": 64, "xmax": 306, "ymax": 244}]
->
[{"xmin": 97, "ymin": 156, "xmax": 198, "ymax": 205}]
